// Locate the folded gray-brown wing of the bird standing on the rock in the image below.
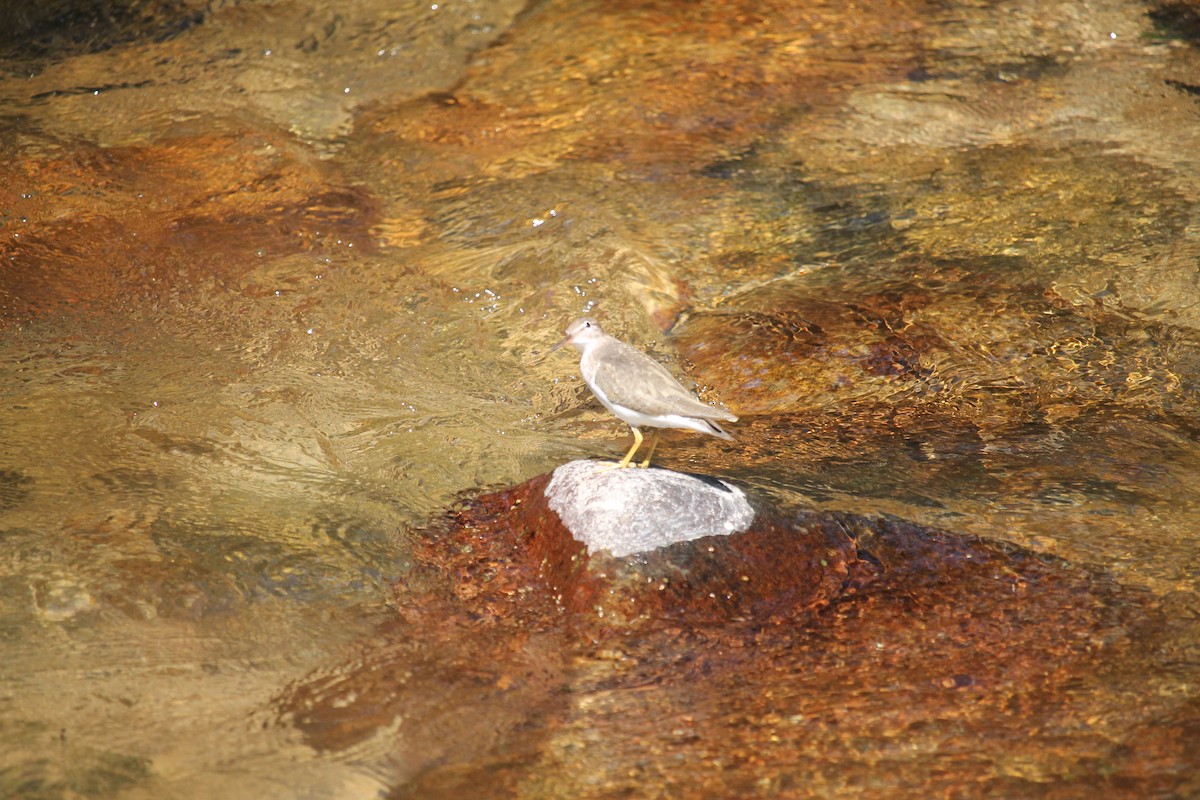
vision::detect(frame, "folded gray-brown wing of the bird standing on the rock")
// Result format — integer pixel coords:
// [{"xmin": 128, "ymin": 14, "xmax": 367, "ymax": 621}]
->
[{"xmin": 594, "ymin": 339, "xmax": 738, "ymax": 422}]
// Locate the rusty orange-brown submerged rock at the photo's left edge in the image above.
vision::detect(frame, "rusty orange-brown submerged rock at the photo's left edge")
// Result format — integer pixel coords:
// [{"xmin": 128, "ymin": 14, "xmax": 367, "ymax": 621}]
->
[{"xmin": 0, "ymin": 125, "xmax": 376, "ymax": 327}]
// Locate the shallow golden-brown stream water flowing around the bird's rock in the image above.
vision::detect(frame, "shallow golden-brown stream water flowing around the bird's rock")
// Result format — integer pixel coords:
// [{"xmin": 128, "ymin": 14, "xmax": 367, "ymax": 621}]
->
[{"xmin": 0, "ymin": 0, "xmax": 1200, "ymax": 798}]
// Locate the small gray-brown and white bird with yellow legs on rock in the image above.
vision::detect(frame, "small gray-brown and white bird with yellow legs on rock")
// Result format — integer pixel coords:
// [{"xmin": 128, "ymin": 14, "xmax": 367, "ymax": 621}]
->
[{"xmin": 550, "ymin": 317, "xmax": 738, "ymax": 469}]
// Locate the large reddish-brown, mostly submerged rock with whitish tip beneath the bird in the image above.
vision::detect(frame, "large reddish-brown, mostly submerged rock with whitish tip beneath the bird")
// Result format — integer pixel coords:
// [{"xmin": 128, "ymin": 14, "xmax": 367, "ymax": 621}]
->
[{"xmin": 278, "ymin": 464, "xmax": 1166, "ymax": 798}]
